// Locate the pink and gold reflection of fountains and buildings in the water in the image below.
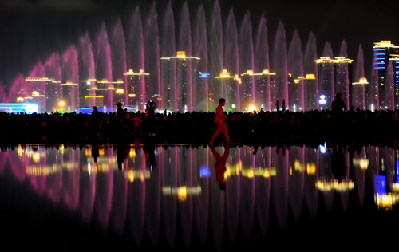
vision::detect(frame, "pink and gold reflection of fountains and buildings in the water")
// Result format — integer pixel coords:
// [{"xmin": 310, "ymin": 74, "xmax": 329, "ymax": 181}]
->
[{"xmin": 9, "ymin": 145, "xmax": 399, "ymax": 247}]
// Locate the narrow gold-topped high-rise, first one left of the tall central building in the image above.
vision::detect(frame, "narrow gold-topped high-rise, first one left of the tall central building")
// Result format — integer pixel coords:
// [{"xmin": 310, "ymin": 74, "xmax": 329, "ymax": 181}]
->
[{"xmin": 124, "ymin": 69, "xmax": 150, "ymax": 110}]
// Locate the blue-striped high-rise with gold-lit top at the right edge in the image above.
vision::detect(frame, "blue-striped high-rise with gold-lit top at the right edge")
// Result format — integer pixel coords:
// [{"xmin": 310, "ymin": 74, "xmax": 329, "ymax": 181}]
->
[{"xmin": 373, "ymin": 41, "xmax": 399, "ymax": 109}]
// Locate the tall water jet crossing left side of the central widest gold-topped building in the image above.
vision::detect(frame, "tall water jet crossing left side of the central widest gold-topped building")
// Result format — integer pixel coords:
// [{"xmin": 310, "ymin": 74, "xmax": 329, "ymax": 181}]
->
[{"xmin": 160, "ymin": 2, "xmax": 177, "ymax": 110}]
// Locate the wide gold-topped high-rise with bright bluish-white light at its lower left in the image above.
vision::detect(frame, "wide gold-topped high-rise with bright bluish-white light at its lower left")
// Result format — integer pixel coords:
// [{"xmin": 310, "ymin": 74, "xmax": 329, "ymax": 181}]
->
[{"xmin": 316, "ymin": 57, "xmax": 353, "ymax": 109}]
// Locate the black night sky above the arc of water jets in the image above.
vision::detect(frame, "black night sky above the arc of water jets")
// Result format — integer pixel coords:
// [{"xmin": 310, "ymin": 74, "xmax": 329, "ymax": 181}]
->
[{"xmin": 0, "ymin": 0, "xmax": 399, "ymax": 85}]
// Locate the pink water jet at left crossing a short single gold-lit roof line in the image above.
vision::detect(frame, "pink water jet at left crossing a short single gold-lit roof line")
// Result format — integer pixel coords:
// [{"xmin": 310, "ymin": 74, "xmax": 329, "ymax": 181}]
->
[{"xmin": 61, "ymin": 45, "xmax": 79, "ymax": 111}]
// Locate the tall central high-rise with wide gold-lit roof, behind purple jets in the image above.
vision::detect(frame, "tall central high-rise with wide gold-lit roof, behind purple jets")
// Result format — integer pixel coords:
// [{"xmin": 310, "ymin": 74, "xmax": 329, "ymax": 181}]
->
[{"xmin": 162, "ymin": 51, "xmax": 200, "ymax": 112}]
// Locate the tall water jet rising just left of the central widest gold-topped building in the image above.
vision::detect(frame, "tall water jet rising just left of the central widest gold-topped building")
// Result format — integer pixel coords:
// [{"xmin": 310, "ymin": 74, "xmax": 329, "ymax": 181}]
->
[{"xmin": 144, "ymin": 2, "xmax": 161, "ymax": 105}]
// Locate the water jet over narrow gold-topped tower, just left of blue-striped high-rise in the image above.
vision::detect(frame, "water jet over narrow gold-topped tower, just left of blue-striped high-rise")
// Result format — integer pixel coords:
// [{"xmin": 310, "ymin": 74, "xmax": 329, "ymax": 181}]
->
[{"xmin": 351, "ymin": 45, "xmax": 370, "ymax": 110}]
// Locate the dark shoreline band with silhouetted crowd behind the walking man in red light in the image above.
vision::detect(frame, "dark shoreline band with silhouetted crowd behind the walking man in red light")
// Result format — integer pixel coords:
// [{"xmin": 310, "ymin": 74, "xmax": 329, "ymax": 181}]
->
[{"xmin": 0, "ymin": 111, "xmax": 399, "ymax": 147}]
